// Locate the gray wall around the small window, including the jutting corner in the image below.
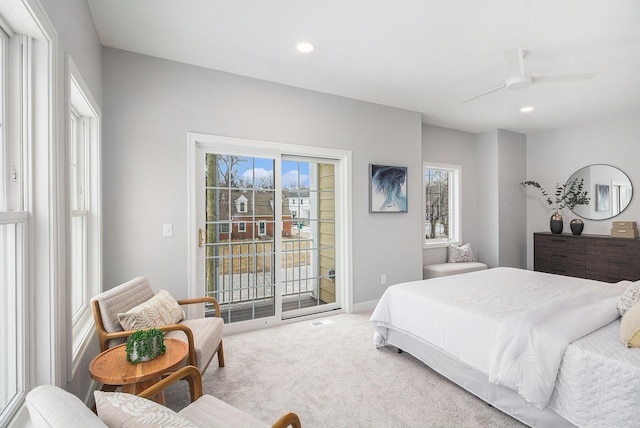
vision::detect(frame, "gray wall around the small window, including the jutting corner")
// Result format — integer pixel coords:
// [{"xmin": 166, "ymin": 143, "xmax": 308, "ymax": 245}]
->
[{"xmin": 422, "ymin": 125, "xmax": 526, "ymax": 267}]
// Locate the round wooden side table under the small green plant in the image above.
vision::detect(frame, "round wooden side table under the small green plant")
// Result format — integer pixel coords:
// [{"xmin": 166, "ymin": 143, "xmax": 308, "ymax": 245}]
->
[{"xmin": 89, "ymin": 339, "xmax": 189, "ymax": 405}]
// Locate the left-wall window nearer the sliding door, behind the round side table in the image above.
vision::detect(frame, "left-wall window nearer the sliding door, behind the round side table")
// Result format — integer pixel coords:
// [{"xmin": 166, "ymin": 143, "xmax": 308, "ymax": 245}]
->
[{"xmin": 68, "ymin": 65, "xmax": 101, "ymax": 380}]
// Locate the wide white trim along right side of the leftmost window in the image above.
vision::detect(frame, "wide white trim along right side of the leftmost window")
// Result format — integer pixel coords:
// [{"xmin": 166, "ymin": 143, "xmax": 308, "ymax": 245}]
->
[{"xmin": 0, "ymin": 0, "xmax": 58, "ymax": 425}]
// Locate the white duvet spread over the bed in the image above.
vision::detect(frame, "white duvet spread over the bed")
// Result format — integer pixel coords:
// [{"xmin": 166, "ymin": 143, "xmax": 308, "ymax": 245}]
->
[{"xmin": 371, "ymin": 268, "xmax": 628, "ymax": 408}]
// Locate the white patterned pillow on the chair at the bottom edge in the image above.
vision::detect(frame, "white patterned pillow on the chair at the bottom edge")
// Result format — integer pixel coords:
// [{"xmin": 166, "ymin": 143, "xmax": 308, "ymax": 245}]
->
[{"xmin": 93, "ymin": 391, "xmax": 197, "ymax": 428}]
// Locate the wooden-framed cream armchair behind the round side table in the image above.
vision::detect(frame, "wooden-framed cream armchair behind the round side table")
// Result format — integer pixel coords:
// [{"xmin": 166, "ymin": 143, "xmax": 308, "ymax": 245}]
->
[{"xmin": 91, "ymin": 276, "xmax": 224, "ymax": 373}]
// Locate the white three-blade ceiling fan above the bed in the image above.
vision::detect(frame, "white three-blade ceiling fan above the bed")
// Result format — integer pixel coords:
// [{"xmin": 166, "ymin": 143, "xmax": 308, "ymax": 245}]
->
[{"xmin": 462, "ymin": 47, "xmax": 598, "ymax": 103}]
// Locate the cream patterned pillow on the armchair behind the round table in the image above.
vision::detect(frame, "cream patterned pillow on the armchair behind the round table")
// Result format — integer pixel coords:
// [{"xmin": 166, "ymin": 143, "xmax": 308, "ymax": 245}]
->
[{"xmin": 118, "ymin": 290, "xmax": 185, "ymax": 330}]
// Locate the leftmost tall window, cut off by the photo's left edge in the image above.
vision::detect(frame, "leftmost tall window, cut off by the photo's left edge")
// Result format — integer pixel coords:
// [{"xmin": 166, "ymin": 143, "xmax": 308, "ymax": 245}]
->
[{"xmin": 0, "ymin": 28, "xmax": 31, "ymax": 426}]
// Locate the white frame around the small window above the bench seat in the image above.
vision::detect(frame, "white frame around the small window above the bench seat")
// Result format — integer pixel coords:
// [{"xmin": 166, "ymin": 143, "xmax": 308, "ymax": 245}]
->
[{"xmin": 422, "ymin": 162, "xmax": 462, "ymax": 248}]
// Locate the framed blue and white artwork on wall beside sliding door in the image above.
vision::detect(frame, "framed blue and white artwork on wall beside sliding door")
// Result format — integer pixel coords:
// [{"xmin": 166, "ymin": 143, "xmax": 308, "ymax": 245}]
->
[{"xmin": 369, "ymin": 164, "xmax": 407, "ymax": 213}]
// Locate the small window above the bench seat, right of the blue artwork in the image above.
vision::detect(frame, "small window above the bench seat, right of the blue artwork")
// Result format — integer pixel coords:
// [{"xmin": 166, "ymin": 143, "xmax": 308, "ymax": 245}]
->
[{"xmin": 423, "ymin": 163, "xmax": 462, "ymax": 246}]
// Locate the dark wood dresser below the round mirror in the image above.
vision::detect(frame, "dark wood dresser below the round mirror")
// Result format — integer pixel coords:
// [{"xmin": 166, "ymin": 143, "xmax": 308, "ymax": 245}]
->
[{"xmin": 533, "ymin": 232, "xmax": 640, "ymax": 282}]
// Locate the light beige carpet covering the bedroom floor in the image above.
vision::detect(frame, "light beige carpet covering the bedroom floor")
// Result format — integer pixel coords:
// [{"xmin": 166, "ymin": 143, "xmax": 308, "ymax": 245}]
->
[{"xmin": 166, "ymin": 314, "xmax": 524, "ymax": 428}]
